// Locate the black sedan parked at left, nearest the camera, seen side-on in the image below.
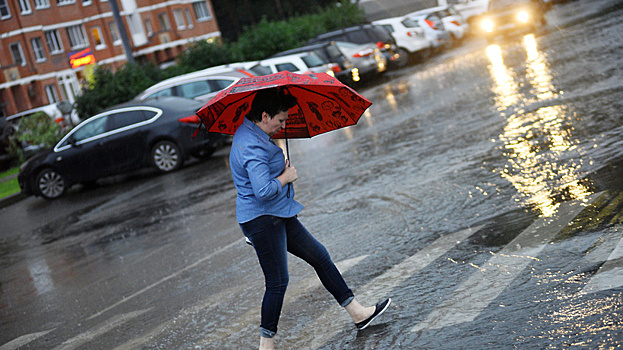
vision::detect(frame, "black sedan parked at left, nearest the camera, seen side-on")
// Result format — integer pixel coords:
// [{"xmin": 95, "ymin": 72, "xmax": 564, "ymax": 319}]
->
[{"xmin": 18, "ymin": 97, "xmax": 226, "ymax": 199}]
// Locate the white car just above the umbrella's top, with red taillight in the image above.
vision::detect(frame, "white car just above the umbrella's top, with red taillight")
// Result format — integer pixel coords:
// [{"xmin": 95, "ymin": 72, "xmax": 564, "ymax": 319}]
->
[{"xmin": 254, "ymin": 52, "xmax": 337, "ymax": 76}]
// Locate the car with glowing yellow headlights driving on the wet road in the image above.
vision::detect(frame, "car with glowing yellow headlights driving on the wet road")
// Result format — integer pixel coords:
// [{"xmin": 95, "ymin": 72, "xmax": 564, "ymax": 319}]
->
[{"xmin": 481, "ymin": 0, "xmax": 547, "ymax": 42}]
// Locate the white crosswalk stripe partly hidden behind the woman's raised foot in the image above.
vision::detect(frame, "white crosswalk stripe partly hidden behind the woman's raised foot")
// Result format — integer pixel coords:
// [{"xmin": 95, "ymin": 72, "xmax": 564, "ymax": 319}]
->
[{"xmin": 296, "ymin": 226, "xmax": 483, "ymax": 349}]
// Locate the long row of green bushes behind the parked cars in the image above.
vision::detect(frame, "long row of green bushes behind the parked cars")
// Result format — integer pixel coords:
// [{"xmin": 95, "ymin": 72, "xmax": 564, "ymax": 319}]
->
[{"xmin": 76, "ymin": 0, "xmax": 365, "ymax": 119}]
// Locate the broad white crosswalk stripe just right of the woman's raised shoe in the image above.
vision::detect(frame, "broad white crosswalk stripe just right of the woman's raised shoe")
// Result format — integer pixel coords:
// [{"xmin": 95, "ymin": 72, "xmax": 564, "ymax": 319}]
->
[{"xmin": 411, "ymin": 193, "xmax": 601, "ymax": 332}]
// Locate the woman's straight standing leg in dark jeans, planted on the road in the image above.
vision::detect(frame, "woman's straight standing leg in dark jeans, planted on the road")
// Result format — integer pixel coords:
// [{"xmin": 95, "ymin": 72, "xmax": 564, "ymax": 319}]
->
[{"xmin": 240, "ymin": 216, "xmax": 289, "ymax": 338}]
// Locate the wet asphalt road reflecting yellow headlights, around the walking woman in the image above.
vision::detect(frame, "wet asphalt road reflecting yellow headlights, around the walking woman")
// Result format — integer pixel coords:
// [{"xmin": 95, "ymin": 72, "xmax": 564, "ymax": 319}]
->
[{"xmin": 0, "ymin": 0, "xmax": 623, "ymax": 350}]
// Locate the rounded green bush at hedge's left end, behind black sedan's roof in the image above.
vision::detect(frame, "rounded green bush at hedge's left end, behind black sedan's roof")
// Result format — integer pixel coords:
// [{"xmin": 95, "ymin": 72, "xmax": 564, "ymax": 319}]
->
[{"xmin": 76, "ymin": 63, "xmax": 162, "ymax": 119}]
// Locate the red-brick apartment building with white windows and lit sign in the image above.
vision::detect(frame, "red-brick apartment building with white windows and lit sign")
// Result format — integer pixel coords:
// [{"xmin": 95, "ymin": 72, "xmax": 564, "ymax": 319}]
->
[{"xmin": 0, "ymin": 0, "xmax": 220, "ymax": 117}]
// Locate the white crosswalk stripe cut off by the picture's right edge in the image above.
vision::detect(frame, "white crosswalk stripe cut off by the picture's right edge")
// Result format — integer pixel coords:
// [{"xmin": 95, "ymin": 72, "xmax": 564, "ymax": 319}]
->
[{"xmin": 581, "ymin": 228, "xmax": 623, "ymax": 294}]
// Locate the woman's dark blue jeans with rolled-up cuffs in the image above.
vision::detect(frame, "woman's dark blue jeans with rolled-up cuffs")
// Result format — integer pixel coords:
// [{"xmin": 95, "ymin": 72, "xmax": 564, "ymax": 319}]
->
[{"xmin": 240, "ymin": 215, "xmax": 354, "ymax": 338}]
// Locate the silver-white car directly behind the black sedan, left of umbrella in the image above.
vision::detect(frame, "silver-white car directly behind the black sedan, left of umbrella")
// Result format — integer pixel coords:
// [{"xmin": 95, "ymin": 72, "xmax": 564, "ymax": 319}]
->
[{"xmin": 135, "ymin": 67, "xmax": 256, "ymax": 101}]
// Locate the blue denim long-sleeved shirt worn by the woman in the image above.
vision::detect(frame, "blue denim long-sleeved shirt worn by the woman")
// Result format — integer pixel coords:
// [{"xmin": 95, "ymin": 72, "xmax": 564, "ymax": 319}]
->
[{"xmin": 229, "ymin": 118, "xmax": 303, "ymax": 224}]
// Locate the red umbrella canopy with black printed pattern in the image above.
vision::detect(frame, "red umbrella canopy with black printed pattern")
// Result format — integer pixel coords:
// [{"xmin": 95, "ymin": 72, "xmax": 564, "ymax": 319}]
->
[{"xmin": 197, "ymin": 71, "xmax": 372, "ymax": 139}]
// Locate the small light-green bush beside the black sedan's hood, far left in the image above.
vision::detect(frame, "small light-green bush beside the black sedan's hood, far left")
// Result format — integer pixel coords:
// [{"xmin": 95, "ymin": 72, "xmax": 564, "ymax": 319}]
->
[{"xmin": 8, "ymin": 112, "xmax": 62, "ymax": 163}]
